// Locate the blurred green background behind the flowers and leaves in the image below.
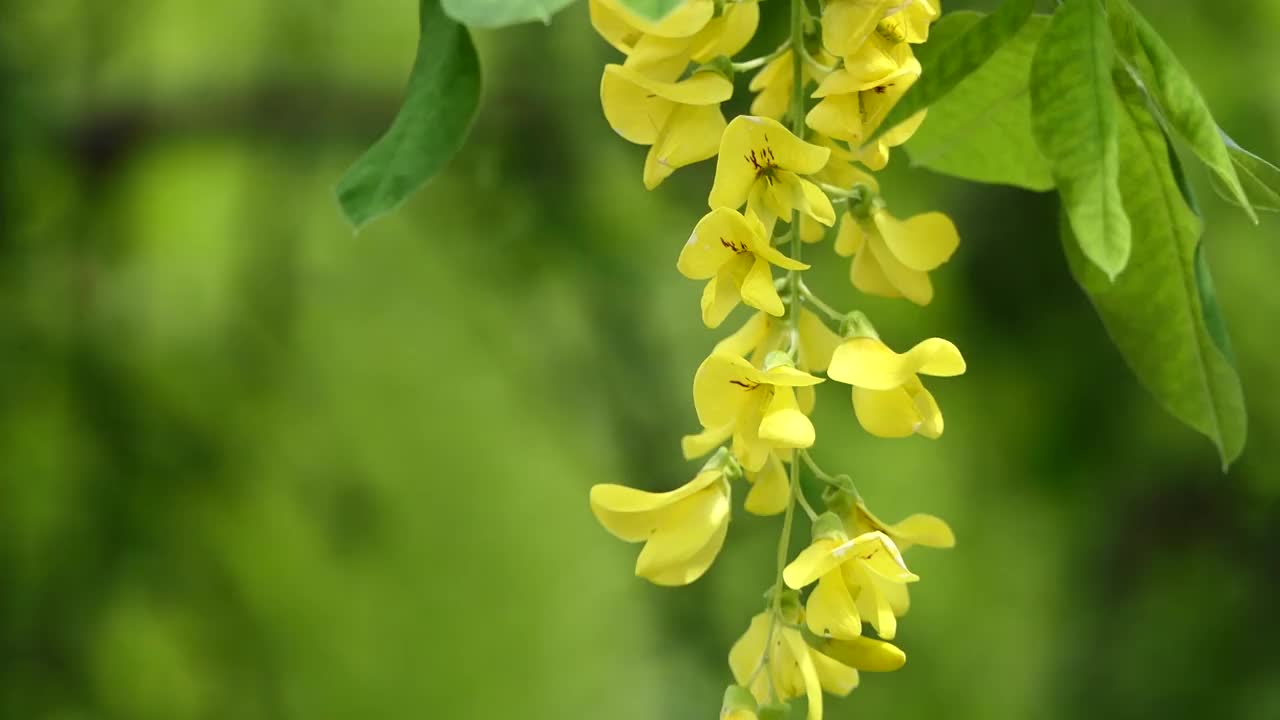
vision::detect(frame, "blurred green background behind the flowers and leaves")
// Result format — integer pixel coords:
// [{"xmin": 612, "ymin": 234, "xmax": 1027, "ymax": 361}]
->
[{"xmin": 0, "ymin": 0, "xmax": 1280, "ymax": 720}]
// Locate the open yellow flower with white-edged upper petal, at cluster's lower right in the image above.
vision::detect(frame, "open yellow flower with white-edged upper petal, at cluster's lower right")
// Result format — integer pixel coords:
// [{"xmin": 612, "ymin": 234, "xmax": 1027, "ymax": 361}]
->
[{"xmin": 782, "ymin": 525, "xmax": 920, "ymax": 641}]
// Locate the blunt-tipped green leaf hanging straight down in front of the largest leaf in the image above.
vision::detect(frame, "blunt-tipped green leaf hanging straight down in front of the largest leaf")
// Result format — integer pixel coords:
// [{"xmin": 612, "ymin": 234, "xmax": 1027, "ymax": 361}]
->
[{"xmin": 1032, "ymin": 0, "xmax": 1130, "ymax": 279}]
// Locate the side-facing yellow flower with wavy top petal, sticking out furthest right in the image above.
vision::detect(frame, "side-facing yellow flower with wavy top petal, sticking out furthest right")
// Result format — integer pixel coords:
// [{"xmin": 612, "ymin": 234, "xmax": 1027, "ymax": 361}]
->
[{"xmin": 827, "ymin": 337, "xmax": 965, "ymax": 438}]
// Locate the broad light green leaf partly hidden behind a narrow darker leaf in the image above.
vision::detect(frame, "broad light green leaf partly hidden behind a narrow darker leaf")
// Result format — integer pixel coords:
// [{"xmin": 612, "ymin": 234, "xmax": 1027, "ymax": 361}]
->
[{"xmin": 906, "ymin": 12, "xmax": 1053, "ymax": 191}]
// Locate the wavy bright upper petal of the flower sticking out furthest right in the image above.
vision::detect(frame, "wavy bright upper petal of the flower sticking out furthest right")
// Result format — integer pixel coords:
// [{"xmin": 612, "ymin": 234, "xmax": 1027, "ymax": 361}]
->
[{"xmin": 827, "ymin": 337, "xmax": 965, "ymax": 389}]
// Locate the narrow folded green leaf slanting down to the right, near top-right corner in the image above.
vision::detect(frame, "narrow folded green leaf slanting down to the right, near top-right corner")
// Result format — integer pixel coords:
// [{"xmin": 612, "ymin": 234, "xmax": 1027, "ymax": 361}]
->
[{"xmin": 1110, "ymin": 0, "xmax": 1258, "ymax": 223}]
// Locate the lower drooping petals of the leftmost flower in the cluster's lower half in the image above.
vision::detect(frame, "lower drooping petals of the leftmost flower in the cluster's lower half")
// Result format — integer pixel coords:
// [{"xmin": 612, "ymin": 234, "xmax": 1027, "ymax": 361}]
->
[{"xmin": 636, "ymin": 486, "xmax": 730, "ymax": 585}]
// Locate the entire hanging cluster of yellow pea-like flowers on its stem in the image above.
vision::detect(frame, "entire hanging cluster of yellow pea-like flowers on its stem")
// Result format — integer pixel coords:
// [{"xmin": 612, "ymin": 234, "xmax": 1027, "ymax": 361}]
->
[{"xmin": 590, "ymin": 0, "xmax": 965, "ymax": 720}]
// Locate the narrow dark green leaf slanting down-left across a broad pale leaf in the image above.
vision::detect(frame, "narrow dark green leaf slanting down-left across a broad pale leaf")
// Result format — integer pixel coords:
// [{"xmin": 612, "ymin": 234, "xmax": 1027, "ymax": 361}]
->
[{"xmin": 864, "ymin": 0, "xmax": 1036, "ymax": 145}]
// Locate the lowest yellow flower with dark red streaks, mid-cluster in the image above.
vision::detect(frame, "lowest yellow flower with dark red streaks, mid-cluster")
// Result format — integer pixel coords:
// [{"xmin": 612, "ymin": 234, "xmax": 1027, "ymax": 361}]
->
[{"xmin": 694, "ymin": 351, "xmax": 823, "ymax": 473}]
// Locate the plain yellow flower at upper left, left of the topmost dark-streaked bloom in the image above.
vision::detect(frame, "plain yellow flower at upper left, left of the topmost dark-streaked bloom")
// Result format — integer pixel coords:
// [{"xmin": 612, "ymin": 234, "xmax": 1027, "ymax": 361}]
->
[{"xmin": 600, "ymin": 65, "xmax": 733, "ymax": 190}]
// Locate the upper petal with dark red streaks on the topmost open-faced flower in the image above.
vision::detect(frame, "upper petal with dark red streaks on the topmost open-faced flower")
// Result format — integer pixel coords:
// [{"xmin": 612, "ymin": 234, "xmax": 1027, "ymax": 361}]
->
[{"xmin": 708, "ymin": 115, "xmax": 831, "ymax": 208}]
